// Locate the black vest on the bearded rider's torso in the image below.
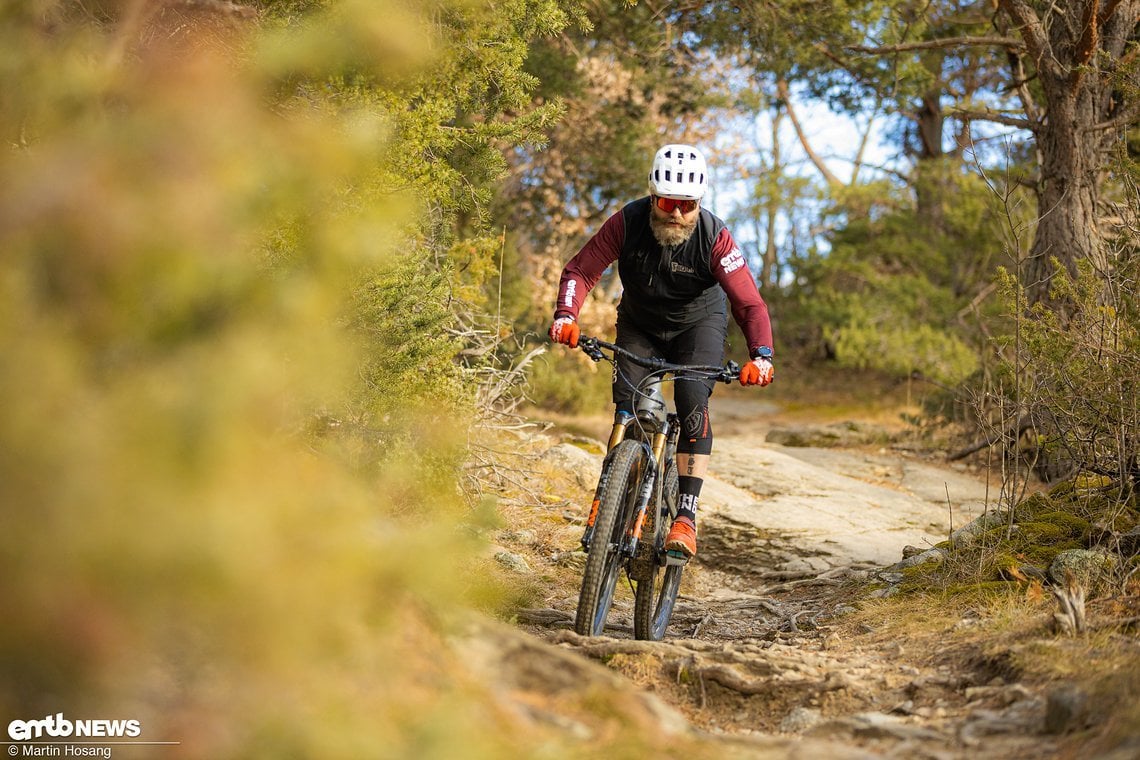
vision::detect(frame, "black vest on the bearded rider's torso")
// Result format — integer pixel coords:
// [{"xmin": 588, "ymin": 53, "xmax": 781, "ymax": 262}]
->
[{"xmin": 618, "ymin": 196, "xmax": 728, "ymax": 333}]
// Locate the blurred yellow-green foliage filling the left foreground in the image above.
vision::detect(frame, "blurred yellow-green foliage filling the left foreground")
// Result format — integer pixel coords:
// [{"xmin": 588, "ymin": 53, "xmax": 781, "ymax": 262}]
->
[{"xmin": 0, "ymin": 3, "xmax": 547, "ymax": 758}]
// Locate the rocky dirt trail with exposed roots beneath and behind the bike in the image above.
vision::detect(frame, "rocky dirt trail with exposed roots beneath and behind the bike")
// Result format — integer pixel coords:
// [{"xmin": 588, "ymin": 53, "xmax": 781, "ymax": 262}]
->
[{"xmin": 501, "ymin": 401, "xmax": 1085, "ymax": 760}]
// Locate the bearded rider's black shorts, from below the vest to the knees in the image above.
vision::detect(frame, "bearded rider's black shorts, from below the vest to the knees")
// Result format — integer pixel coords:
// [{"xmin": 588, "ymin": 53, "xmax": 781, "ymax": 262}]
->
[{"xmin": 613, "ymin": 310, "xmax": 728, "ymax": 438}]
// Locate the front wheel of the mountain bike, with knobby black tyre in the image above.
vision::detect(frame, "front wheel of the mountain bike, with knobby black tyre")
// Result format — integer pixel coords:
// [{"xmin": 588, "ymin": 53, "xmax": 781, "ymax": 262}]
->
[{"xmin": 573, "ymin": 441, "xmax": 645, "ymax": 636}]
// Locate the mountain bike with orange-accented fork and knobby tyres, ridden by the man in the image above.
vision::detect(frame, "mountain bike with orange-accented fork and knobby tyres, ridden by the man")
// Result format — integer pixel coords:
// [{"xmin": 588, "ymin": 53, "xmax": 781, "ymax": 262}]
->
[{"xmin": 575, "ymin": 336, "xmax": 740, "ymax": 641}]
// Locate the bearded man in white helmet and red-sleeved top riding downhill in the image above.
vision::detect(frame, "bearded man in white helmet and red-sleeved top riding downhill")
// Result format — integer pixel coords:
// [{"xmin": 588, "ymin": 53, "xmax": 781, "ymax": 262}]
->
[{"xmin": 549, "ymin": 144, "xmax": 774, "ymax": 557}]
